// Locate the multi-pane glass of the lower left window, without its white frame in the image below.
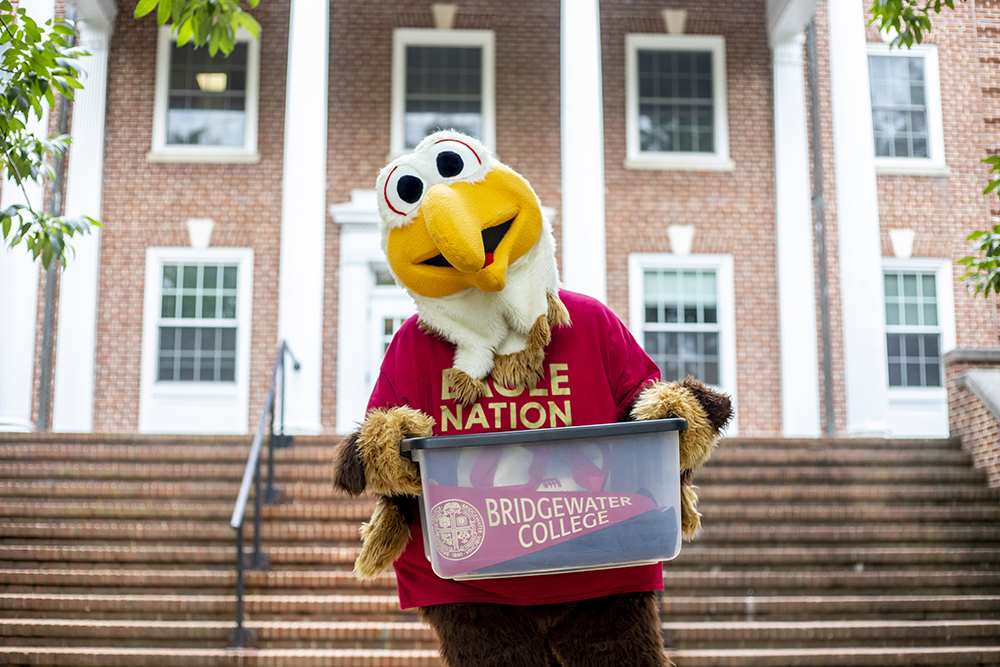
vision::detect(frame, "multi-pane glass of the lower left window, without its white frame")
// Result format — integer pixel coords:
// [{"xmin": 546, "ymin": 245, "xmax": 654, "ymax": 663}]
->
[{"xmin": 156, "ymin": 263, "xmax": 239, "ymax": 382}]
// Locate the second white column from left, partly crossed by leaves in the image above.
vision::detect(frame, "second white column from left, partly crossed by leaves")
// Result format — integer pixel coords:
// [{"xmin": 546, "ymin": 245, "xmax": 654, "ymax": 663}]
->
[{"xmin": 52, "ymin": 20, "xmax": 111, "ymax": 432}]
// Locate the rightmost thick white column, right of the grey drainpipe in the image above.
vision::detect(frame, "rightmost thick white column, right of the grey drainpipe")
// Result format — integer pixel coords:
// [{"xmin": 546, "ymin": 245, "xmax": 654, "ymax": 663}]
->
[{"xmin": 828, "ymin": 0, "xmax": 889, "ymax": 436}]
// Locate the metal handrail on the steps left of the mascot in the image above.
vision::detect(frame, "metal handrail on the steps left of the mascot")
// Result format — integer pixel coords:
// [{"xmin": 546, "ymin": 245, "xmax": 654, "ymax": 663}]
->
[{"xmin": 229, "ymin": 341, "xmax": 301, "ymax": 648}]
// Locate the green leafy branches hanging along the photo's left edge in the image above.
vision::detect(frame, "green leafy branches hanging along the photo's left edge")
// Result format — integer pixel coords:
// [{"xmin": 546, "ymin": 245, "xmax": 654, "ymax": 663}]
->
[{"xmin": 0, "ymin": 0, "xmax": 99, "ymax": 267}]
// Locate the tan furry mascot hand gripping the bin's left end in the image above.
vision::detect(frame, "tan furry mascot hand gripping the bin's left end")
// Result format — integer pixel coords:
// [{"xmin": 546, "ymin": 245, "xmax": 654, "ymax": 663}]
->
[{"xmin": 357, "ymin": 406, "xmax": 434, "ymax": 496}]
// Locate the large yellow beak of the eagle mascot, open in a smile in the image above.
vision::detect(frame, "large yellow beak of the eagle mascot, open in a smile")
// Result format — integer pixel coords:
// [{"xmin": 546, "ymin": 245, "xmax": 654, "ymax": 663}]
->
[{"xmin": 386, "ymin": 165, "xmax": 542, "ymax": 297}]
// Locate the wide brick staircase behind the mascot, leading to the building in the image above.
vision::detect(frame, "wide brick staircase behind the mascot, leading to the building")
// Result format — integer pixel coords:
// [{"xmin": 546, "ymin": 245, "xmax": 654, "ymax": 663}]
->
[{"xmin": 0, "ymin": 434, "xmax": 1000, "ymax": 667}]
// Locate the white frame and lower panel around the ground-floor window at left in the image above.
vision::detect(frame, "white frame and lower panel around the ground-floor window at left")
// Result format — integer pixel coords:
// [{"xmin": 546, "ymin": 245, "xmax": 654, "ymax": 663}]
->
[{"xmin": 139, "ymin": 247, "xmax": 253, "ymax": 434}]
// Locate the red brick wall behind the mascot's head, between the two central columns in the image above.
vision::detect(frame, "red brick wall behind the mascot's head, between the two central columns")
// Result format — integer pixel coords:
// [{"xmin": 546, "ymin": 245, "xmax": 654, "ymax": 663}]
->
[{"xmin": 322, "ymin": 0, "xmax": 561, "ymax": 430}]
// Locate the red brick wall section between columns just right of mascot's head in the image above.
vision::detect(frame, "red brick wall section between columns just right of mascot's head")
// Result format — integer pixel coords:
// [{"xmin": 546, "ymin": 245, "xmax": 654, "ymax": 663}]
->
[{"xmin": 601, "ymin": 0, "xmax": 781, "ymax": 435}]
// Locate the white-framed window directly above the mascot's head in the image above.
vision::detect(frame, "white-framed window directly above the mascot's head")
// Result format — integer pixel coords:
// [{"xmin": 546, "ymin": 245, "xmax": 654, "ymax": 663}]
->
[{"xmin": 391, "ymin": 29, "xmax": 496, "ymax": 155}]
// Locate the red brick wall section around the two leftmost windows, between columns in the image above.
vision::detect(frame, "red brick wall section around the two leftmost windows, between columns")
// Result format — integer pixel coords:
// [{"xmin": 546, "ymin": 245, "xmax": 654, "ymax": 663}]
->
[{"xmin": 94, "ymin": 0, "xmax": 288, "ymax": 431}]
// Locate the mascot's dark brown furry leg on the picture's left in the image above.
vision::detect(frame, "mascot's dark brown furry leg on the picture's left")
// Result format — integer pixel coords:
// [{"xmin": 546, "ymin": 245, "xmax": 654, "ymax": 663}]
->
[{"xmin": 420, "ymin": 603, "xmax": 550, "ymax": 667}]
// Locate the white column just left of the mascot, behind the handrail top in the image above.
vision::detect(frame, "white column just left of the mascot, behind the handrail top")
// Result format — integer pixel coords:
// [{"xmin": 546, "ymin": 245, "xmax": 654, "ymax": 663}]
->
[{"xmin": 275, "ymin": 0, "xmax": 330, "ymax": 433}]
